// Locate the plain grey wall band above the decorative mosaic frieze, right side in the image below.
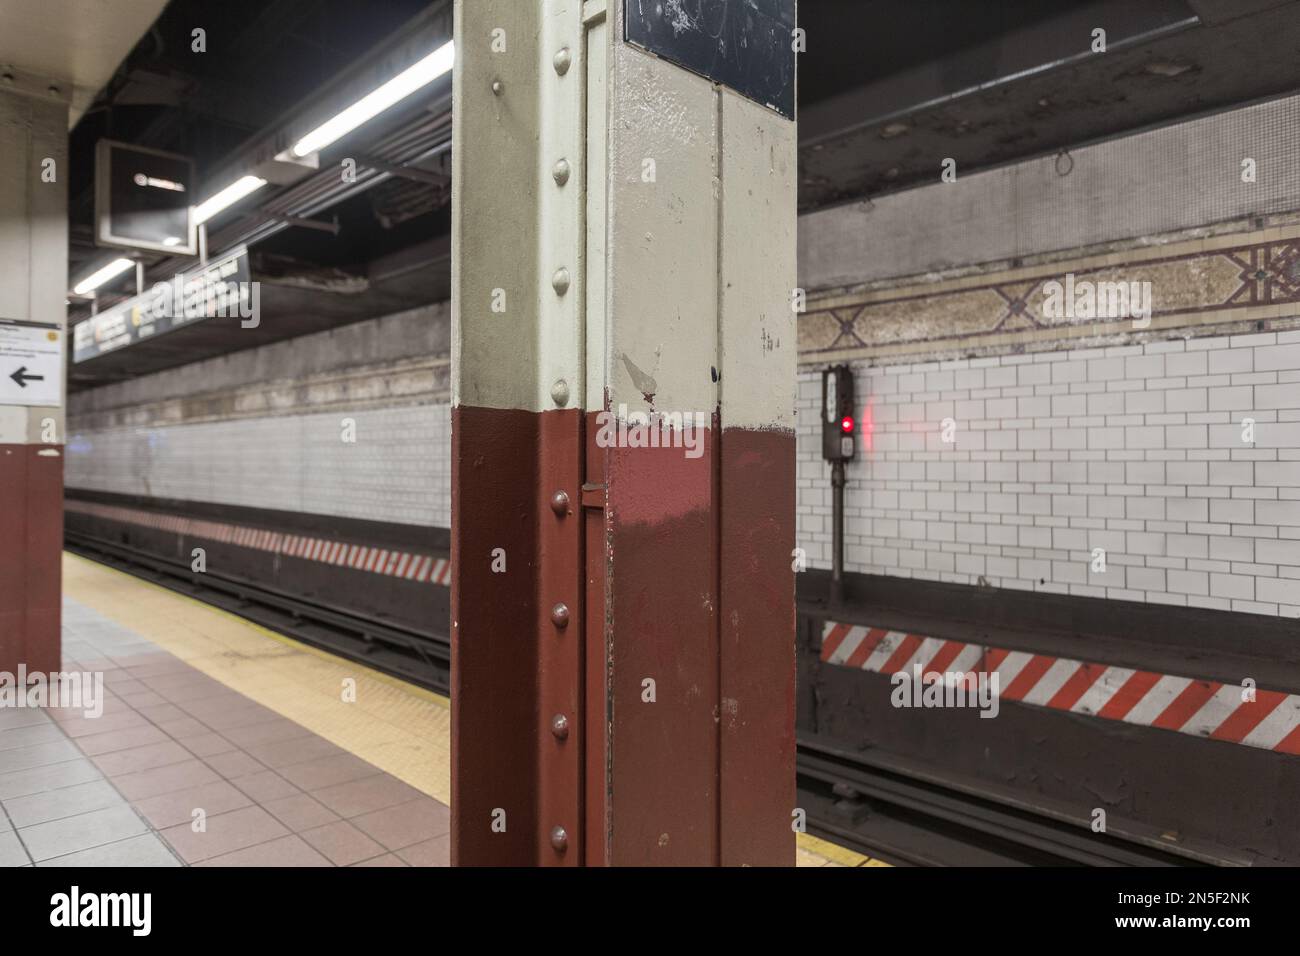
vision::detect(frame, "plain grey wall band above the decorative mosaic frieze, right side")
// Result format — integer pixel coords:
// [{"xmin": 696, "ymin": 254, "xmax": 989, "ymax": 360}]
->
[{"xmin": 800, "ymin": 96, "xmax": 1300, "ymax": 295}]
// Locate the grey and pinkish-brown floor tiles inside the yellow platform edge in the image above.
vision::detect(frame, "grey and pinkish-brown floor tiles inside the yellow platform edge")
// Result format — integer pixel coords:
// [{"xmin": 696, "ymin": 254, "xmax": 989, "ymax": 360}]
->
[{"xmin": 0, "ymin": 598, "xmax": 450, "ymax": 866}]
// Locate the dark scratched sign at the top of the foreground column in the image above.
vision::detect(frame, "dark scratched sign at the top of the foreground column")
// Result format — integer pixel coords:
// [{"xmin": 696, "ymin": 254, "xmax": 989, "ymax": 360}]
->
[{"xmin": 624, "ymin": 0, "xmax": 796, "ymax": 120}]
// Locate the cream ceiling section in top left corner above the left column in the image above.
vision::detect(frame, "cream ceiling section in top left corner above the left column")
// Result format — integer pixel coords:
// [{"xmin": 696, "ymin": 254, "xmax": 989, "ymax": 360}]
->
[{"xmin": 0, "ymin": 0, "xmax": 166, "ymax": 129}]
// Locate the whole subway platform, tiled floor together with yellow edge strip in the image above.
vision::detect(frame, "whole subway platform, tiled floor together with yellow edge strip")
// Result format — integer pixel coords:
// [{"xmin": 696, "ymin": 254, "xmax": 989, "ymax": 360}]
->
[{"xmin": 0, "ymin": 554, "xmax": 883, "ymax": 866}]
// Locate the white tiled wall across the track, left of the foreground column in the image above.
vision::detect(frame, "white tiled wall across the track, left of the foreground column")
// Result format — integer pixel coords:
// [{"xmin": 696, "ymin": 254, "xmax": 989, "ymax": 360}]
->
[{"xmin": 65, "ymin": 405, "xmax": 451, "ymax": 528}]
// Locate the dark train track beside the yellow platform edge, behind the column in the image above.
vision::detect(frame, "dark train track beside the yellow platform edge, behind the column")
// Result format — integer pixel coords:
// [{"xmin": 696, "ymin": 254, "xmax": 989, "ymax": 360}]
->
[{"xmin": 65, "ymin": 531, "xmax": 1216, "ymax": 866}]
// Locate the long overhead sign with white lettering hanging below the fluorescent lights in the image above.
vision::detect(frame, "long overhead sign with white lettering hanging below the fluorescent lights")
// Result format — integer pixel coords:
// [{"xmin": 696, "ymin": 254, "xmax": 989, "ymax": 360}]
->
[{"xmin": 73, "ymin": 247, "xmax": 257, "ymax": 363}]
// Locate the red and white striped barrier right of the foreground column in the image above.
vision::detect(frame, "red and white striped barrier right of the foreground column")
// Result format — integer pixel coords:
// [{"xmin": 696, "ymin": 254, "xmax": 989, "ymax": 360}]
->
[{"xmin": 822, "ymin": 620, "xmax": 1300, "ymax": 754}]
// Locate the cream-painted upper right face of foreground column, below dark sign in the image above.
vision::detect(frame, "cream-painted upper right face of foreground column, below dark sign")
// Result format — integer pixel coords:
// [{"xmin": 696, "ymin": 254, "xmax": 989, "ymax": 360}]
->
[{"xmin": 588, "ymin": 3, "xmax": 796, "ymax": 429}]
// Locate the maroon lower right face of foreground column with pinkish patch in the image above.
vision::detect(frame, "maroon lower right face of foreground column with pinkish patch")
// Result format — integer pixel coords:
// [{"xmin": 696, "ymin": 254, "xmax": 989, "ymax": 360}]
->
[{"xmin": 588, "ymin": 418, "xmax": 794, "ymax": 866}]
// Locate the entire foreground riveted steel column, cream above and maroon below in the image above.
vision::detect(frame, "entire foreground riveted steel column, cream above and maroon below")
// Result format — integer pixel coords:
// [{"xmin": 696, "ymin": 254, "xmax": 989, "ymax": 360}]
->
[{"xmin": 452, "ymin": 0, "xmax": 796, "ymax": 865}]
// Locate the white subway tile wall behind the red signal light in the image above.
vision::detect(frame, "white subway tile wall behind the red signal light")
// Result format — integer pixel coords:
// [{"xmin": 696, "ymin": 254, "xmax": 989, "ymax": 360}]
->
[{"xmin": 798, "ymin": 332, "xmax": 1300, "ymax": 618}]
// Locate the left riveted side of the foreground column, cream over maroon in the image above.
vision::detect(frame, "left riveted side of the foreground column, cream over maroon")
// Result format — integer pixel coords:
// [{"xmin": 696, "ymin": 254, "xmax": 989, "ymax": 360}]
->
[{"xmin": 451, "ymin": 0, "xmax": 585, "ymax": 865}]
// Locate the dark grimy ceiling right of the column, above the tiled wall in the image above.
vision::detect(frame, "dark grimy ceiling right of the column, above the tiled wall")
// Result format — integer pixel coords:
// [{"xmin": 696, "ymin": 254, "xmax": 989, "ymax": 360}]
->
[{"xmin": 800, "ymin": 0, "xmax": 1300, "ymax": 211}]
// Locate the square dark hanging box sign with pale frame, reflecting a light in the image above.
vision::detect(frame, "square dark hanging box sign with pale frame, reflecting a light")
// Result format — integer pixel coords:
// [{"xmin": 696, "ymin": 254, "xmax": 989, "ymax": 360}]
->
[{"xmin": 95, "ymin": 139, "xmax": 198, "ymax": 255}]
